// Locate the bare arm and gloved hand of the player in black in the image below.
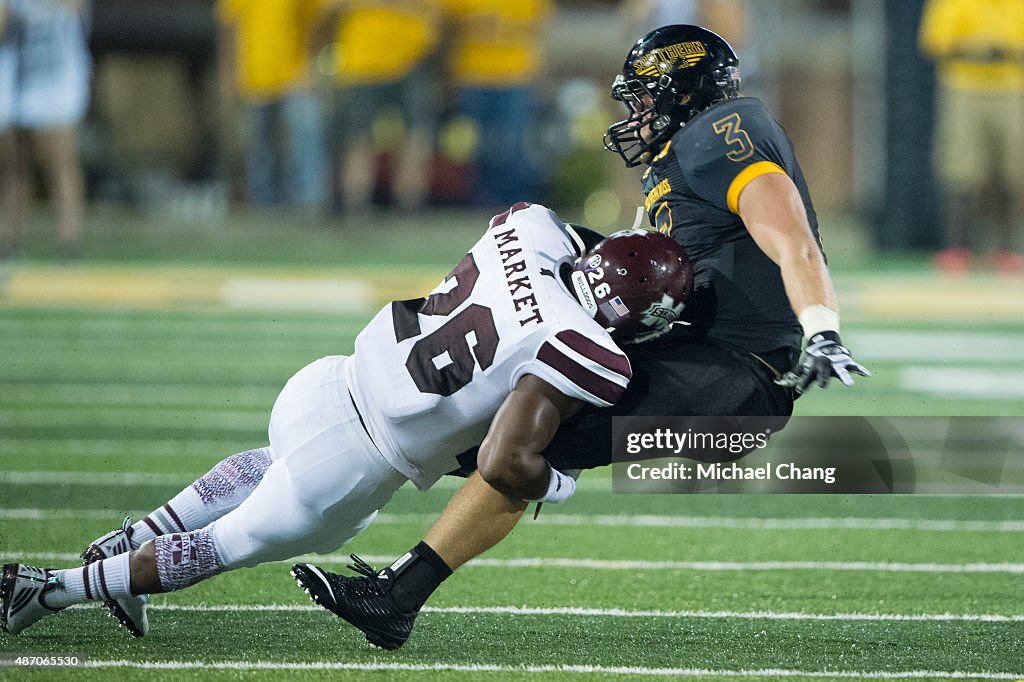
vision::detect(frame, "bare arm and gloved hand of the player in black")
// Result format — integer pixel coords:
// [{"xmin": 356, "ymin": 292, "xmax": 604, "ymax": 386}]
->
[{"xmin": 738, "ymin": 173, "xmax": 870, "ymax": 394}]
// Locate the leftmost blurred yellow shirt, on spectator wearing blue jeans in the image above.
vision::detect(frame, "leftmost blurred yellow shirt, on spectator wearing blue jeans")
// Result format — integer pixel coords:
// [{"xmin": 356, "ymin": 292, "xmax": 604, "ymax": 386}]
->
[{"xmin": 217, "ymin": 0, "xmax": 323, "ymax": 99}]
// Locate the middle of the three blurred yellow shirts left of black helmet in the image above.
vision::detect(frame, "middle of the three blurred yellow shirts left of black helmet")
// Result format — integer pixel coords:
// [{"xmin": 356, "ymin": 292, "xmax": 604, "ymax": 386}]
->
[{"xmin": 335, "ymin": 0, "xmax": 440, "ymax": 85}]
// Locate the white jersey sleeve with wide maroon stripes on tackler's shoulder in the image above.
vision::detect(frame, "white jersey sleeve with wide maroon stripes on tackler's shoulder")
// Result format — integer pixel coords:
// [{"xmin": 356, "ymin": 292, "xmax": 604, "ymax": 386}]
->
[{"xmin": 513, "ymin": 329, "xmax": 633, "ymax": 408}]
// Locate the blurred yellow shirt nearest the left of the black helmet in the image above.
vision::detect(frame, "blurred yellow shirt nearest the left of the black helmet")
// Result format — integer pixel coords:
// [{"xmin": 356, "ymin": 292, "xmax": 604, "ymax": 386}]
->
[{"xmin": 445, "ymin": 0, "xmax": 551, "ymax": 87}]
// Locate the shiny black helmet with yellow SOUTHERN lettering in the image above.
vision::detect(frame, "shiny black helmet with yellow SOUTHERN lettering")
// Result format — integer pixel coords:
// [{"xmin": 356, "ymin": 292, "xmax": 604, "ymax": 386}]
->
[{"xmin": 604, "ymin": 24, "xmax": 739, "ymax": 167}]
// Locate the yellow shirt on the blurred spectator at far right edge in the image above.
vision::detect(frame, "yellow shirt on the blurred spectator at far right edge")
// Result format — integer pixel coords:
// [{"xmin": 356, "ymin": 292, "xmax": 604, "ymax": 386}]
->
[{"xmin": 920, "ymin": 0, "xmax": 1024, "ymax": 90}]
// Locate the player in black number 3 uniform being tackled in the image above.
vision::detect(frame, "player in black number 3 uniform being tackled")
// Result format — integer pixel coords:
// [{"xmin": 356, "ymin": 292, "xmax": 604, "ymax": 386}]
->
[{"xmin": 292, "ymin": 25, "xmax": 868, "ymax": 645}]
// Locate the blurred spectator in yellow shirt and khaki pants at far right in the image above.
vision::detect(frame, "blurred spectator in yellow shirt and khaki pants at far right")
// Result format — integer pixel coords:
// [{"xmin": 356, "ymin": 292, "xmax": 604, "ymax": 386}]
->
[{"xmin": 920, "ymin": 0, "xmax": 1024, "ymax": 273}]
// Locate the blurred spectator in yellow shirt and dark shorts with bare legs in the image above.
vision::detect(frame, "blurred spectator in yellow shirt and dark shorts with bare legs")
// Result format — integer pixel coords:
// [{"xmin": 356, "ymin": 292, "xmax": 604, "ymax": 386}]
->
[{"xmin": 328, "ymin": 0, "xmax": 441, "ymax": 214}]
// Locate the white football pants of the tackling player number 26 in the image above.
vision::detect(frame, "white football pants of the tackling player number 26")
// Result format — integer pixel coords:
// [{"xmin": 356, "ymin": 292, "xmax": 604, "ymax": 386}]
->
[{"xmin": 213, "ymin": 355, "xmax": 407, "ymax": 568}]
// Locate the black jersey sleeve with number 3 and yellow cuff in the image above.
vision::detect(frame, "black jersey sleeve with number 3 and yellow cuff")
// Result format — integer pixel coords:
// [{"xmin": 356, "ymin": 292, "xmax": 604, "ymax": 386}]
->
[{"xmin": 673, "ymin": 100, "xmax": 788, "ymax": 214}]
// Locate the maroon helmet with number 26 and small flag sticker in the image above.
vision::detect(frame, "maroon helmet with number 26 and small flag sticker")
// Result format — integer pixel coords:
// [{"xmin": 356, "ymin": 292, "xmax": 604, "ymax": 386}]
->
[{"xmin": 570, "ymin": 229, "xmax": 693, "ymax": 343}]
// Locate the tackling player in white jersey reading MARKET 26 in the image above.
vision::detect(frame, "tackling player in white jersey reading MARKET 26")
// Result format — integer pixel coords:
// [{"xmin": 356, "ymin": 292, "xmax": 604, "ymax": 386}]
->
[{"xmin": 0, "ymin": 204, "xmax": 692, "ymax": 644}]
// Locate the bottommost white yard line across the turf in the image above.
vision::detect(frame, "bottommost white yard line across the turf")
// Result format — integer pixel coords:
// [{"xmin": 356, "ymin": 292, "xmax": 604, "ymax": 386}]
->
[{"xmin": 74, "ymin": 660, "xmax": 1024, "ymax": 680}]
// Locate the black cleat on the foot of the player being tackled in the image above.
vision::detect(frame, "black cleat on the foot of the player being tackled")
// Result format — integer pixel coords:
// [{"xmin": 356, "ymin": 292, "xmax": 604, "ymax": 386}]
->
[{"xmin": 292, "ymin": 554, "xmax": 419, "ymax": 649}]
